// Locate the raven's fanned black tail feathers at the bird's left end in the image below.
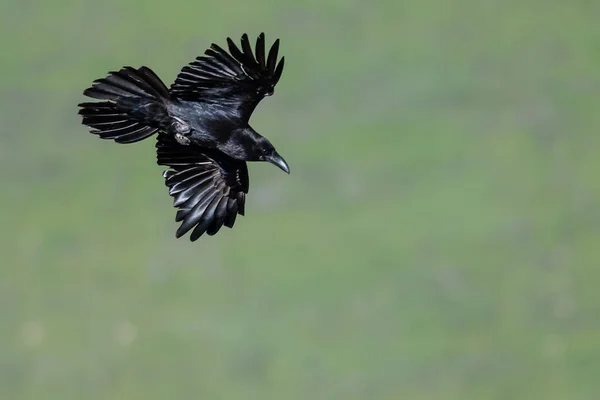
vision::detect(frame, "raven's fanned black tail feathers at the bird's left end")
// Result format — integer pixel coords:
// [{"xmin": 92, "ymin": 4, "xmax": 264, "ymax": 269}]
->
[{"xmin": 79, "ymin": 67, "xmax": 169, "ymax": 143}]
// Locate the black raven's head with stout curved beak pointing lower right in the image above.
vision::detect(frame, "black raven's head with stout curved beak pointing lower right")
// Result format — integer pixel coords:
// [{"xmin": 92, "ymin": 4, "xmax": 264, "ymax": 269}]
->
[{"xmin": 220, "ymin": 127, "xmax": 290, "ymax": 174}]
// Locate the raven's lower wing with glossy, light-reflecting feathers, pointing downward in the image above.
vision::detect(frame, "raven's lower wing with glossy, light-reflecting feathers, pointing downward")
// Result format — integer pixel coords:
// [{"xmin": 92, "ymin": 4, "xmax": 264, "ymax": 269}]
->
[{"xmin": 156, "ymin": 132, "xmax": 249, "ymax": 241}]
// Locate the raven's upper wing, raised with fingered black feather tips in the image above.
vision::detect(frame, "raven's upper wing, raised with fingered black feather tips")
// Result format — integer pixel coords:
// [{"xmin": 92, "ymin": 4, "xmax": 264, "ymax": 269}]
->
[{"xmin": 170, "ymin": 33, "xmax": 284, "ymax": 122}]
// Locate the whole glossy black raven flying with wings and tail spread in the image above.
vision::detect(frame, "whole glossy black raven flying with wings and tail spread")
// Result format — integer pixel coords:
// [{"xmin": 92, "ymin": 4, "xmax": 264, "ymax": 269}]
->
[{"xmin": 79, "ymin": 33, "xmax": 290, "ymax": 241}]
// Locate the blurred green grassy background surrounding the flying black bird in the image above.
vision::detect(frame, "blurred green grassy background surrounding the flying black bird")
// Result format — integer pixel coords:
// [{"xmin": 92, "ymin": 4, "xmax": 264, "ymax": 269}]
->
[{"xmin": 0, "ymin": 0, "xmax": 600, "ymax": 400}]
